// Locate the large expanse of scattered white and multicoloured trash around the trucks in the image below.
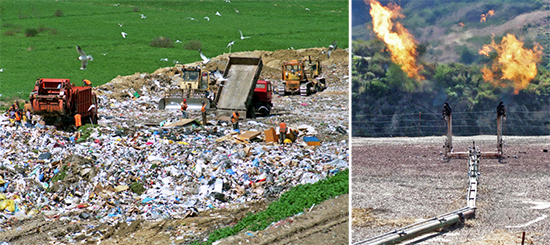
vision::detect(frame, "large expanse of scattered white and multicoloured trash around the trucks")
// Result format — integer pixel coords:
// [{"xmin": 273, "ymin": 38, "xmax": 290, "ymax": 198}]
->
[{"xmin": 0, "ymin": 49, "xmax": 350, "ymax": 244}]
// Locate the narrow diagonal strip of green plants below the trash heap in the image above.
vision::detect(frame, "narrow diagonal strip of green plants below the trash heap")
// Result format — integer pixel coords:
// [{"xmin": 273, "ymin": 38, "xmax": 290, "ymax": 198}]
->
[{"xmin": 192, "ymin": 169, "xmax": 350, "ymax": 245}]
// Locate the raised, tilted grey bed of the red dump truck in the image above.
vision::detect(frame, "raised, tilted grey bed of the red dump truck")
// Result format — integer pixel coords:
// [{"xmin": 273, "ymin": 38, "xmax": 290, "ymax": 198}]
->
[{"xmin": 217, "ymin": 57, "xmax": 263, "ymax": 111}]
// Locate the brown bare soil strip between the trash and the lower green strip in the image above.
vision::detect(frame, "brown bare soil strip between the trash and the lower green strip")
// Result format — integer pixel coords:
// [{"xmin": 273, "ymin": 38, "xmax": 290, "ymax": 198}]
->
[{"xmin": 0, "ymin": 201, "xmax": 268, "ymax": 244}]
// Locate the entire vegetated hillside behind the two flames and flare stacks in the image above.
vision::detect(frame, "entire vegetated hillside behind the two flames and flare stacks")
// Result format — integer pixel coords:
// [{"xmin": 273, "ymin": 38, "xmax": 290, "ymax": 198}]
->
[{"xmin": 351, "ymin": 1, "xmax": 550, "ymax": 136}]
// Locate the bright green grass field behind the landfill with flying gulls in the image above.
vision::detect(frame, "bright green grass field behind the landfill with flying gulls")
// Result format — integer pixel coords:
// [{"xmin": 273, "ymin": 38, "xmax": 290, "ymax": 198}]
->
[{"xmin": 0, "ymin": 0, "xmax": 350, "ymax": 100}]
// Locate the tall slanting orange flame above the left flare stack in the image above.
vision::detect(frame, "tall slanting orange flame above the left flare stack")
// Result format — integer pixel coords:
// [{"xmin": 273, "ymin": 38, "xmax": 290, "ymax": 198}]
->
[{"xmin": 364, "ymin": 0, "xmax": 423, "ymax": 80}]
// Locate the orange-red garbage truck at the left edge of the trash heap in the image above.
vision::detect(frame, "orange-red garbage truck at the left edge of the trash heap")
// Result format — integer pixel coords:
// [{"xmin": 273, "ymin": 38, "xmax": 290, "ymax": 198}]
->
[{"xmin": 29, "ymin": 78, "xmax": 97, "ymax": 125}]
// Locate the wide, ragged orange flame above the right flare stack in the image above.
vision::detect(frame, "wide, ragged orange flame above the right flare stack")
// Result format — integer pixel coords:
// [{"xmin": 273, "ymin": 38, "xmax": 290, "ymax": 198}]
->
[{"xmin": 479, "ymin": 34, "xmax": 542, "ymax": 94}]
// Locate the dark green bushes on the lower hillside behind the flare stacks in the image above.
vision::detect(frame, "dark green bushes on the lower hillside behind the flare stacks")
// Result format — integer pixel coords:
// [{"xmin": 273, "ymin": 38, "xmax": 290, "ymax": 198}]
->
[{"xmin": 351, "ymin": 40, "xmax": 550, "ymax": 136}]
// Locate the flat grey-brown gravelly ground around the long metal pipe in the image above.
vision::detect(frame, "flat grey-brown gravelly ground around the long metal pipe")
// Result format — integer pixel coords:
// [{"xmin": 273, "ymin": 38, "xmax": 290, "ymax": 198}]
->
[{"xmin": 350, "ymin": 136, "xmax": 550, "ymax": 244}]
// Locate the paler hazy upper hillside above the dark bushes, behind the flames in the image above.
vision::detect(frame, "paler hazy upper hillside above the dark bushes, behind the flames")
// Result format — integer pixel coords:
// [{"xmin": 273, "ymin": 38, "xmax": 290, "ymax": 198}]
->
[{"xmin": 351, "ymin": 0, "xmax": 550, "ymax": 64}]
